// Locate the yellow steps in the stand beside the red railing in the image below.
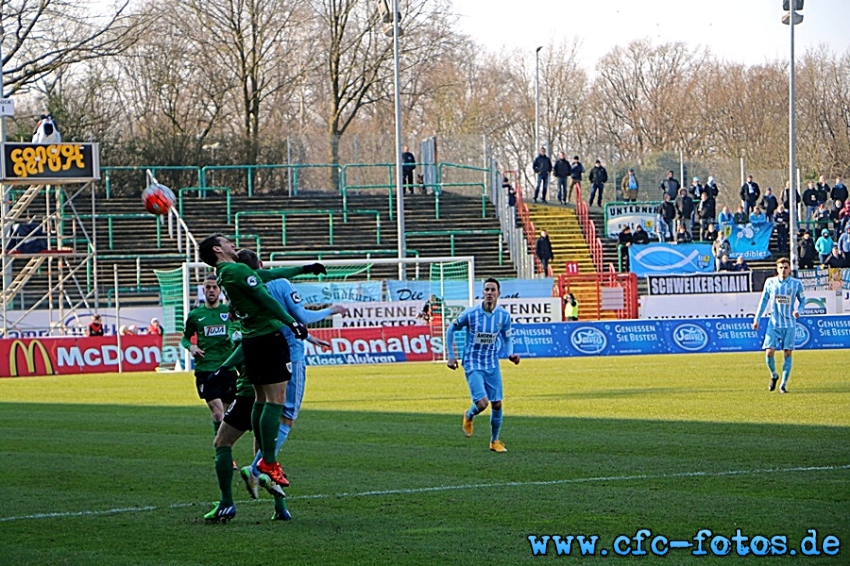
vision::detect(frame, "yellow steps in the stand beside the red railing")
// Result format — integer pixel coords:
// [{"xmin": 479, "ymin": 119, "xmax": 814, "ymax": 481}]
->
[{"xmin": 528, "ymin": 203, "xmax": 596, "ymax": 276}]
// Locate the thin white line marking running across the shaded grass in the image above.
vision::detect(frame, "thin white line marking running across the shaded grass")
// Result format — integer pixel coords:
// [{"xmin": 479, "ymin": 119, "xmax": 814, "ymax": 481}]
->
[{"xmin": 0, "ymin": 464, "xmax": 850, "ymax": 523}]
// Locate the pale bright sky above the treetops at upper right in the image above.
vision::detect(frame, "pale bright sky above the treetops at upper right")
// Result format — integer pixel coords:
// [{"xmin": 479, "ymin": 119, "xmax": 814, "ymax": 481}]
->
[{"xmin": 454, "ymin": 0, "xmax": 850, "ymax": 70}]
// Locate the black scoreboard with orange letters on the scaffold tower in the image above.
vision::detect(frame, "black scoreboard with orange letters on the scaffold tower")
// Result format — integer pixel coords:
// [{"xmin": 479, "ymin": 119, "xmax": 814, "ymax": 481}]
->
[{"xmin": 0, "ymin": 143, "xmax": 100, "ymax": 183}]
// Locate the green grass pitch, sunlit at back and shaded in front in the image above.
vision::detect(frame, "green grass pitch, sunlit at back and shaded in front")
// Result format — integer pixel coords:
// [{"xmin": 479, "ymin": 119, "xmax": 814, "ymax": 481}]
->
[{"xmin": 0, "ymin": 351, "xmax": 850, "ymax": 566}]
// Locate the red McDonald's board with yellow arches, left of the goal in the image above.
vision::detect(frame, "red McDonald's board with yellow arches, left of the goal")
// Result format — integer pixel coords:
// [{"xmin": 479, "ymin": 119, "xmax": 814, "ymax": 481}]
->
[{"xmin": 0, "ymin": 334, "xmax": 166, "ymax": 377}]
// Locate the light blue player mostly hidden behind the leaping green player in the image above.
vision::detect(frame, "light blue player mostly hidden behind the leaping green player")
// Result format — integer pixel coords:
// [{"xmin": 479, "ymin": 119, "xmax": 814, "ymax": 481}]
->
[{"xmin": 236, "ymin": 249, "xmax": 348, "ymax": 520}]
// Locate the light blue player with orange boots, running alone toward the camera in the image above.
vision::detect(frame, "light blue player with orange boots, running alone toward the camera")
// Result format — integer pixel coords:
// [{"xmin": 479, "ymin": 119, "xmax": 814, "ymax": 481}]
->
[{"xmin": 446, "ymin": 277, "xmax": 519, "ymax": 452}]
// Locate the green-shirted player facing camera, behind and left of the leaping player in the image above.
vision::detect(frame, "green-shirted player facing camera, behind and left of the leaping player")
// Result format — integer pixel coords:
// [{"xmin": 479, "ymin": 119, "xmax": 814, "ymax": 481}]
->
[{"xmin": 180, "ymin": 274, "xmax": 236, "ymax": 432}]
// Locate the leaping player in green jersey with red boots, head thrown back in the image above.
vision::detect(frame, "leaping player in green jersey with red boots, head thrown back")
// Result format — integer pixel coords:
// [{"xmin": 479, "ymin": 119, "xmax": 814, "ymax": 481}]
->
[{"xmin": 198, "ymin": 233, "xmax": 325, "ymax": 519}]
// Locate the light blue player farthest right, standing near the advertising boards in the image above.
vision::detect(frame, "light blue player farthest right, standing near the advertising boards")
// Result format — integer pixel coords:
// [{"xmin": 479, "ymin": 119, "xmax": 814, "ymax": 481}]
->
[{"xmin": 753, "ymin": 257, "xmax": 806, "ymax": 393}]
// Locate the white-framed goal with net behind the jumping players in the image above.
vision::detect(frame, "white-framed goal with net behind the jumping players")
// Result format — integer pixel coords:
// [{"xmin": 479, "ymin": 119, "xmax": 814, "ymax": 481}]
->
[{"xmin": 156, "ymin": 256, "xmax": 475, "ymax": 370}]
